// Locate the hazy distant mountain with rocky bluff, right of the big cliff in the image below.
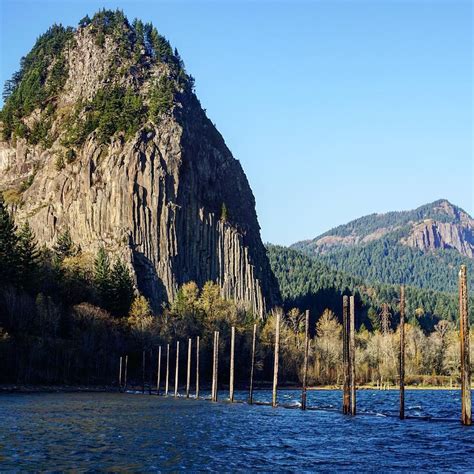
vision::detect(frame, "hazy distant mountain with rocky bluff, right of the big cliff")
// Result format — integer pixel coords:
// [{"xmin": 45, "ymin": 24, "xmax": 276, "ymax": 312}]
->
[{"xmin": 291, "ymin": 199, "xmax": 474, "ymax": 292}]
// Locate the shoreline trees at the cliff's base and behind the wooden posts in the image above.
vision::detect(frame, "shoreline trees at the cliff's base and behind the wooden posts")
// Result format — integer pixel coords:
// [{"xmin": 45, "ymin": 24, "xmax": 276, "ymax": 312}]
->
[{"xmin": 0, "ymin": 198, "xmax": 474, "ymax": 385}]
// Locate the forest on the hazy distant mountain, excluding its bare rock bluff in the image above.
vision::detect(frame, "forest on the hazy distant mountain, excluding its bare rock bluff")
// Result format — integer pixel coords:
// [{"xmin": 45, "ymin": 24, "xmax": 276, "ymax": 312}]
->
[{"xmin": 292, "ymin": 200, "xmax": 474, "ymax": 292}]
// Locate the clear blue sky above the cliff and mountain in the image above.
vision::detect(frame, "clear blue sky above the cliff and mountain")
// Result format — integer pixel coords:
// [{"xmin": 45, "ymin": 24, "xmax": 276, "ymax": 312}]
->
[{"xmin": 0, "ymin": 0, "xmax": 474, "ymax": 244}]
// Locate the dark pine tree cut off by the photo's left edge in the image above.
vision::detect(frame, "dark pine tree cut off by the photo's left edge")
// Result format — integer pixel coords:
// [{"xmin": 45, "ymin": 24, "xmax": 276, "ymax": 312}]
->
[{"xmin": 0, "ymin": 193, "xmax": 18, "ymax": 285}]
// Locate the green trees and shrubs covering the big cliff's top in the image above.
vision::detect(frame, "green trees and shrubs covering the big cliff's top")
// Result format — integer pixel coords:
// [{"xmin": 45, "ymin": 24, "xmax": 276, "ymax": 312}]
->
[{"xmin": 0, "ymin": 9, "xmax": 194, "ymax": 150}]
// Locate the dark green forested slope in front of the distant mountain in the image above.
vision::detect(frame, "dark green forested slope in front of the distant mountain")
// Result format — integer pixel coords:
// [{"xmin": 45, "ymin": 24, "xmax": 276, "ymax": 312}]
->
[{"xmin": 267, "ymin": 245, "xmax": 474, "ymax": 331}]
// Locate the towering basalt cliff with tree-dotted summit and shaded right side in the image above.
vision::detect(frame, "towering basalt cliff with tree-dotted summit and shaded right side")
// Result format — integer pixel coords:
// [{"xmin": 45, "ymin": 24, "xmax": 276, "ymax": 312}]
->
[{"xmin": 0, "ymin": 12, "xmax": 280, "ymax": 316}]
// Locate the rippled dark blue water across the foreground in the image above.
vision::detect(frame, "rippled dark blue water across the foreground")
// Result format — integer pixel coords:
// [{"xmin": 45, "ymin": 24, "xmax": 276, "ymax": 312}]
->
[{"xmin": 0, "ymin": 390, "xmax": 474, "ymax": 472}]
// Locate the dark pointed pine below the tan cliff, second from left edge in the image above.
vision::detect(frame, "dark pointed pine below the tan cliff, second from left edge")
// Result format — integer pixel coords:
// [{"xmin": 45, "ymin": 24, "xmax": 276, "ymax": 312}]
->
[{"xmin": 17, "ymin": 222, "xmax": 40, "ymax": 290}]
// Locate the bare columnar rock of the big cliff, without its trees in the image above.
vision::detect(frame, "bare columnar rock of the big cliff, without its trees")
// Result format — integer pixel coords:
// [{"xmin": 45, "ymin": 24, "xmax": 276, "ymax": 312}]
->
[{"xmin": 0, "ymin": 15, "xmax": 280, "ymax": 316}]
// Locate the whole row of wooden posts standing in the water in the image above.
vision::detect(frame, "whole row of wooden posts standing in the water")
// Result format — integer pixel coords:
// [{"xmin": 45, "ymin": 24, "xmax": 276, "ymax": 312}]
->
[{"xmin": 119, "ymin": 265, "xmax": 472, "ymax": 425}]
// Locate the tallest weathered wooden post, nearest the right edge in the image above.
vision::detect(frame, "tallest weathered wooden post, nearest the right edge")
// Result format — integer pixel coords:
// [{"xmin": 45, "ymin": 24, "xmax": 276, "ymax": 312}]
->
[{"xmin": 459, "ymin": 265, "xmax": 472, "ymax": 425}]
